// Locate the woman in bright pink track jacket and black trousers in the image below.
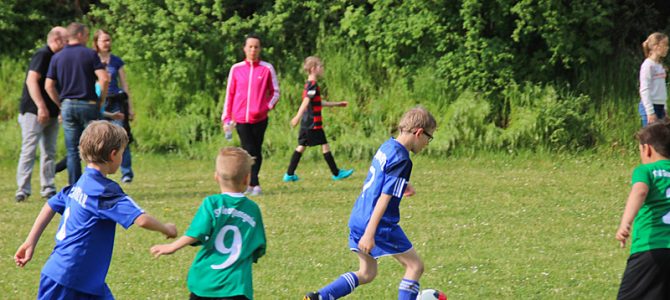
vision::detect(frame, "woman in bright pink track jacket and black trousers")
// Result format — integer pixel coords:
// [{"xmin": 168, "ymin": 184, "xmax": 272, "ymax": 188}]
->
[{"xmin": 221, "ymin": 35, "xmax": 279, "ymax": 195}]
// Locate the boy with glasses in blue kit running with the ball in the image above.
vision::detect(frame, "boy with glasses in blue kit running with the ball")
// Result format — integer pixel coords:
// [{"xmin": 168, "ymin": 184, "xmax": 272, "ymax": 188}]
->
[{"xmin": 304, "ymin": 107, "xmax": 437, "ymax": 300}]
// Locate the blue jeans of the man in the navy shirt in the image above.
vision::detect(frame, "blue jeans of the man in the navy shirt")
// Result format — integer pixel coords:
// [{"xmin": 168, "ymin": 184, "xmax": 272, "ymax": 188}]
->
[{"xmin": 61, "ymin": 99, "xmax": 100, "ymax": 185}]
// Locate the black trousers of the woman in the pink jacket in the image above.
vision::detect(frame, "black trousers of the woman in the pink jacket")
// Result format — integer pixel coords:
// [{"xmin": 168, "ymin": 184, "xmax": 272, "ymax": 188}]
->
[{"xmin": 235, "ymin": 118, "xmax": 268, "ymax": 186}]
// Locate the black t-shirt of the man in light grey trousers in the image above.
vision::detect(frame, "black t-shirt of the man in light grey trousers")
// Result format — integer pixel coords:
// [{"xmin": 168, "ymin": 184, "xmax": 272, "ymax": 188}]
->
[{"xmin": 19, "ymin": 46, "xmax": 60, "ymax": 118}]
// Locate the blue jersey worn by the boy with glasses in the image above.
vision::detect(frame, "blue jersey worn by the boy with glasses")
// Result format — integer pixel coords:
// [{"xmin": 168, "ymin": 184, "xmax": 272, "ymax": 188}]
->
[{"xmin": 349, "ymin": 138, "xmax": 412, "ymax": 235}]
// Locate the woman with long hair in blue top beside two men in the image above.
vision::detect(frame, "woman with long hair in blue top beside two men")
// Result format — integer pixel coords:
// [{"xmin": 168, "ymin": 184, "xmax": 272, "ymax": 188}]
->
[{"xmin": 93, "ymin": 29, "xmax": 135, "ymax": 183}]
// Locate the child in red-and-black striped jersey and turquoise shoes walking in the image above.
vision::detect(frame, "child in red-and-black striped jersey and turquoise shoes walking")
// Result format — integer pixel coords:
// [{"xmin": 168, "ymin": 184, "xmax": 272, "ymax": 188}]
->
[{"xmin": 283, "ymin": 56, "xmax": 354, "ymax": 182}]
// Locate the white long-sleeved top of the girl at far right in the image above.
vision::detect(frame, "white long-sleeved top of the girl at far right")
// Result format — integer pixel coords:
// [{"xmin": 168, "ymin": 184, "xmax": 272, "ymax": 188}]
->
[{"xmin": 640, "ymin": 58, "xmax": 668, "ymax": 115}]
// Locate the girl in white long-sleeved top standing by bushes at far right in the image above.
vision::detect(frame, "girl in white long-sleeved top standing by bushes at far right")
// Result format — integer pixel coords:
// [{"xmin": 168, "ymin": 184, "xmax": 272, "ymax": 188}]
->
[{"xmin": 638, "ymin": 32, "xmax": 668, "ymax": 127}]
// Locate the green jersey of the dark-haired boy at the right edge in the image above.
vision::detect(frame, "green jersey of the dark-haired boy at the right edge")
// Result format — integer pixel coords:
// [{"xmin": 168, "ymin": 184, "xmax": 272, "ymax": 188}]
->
[{"xmin": 630, "ymin": 160, "xmax": 670, "ymax": 254}]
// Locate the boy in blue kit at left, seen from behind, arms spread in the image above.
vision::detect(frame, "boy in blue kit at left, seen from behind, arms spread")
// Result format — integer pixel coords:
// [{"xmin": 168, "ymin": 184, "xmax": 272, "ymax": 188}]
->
[{"xmin": 14, "ymin": 121, "xmax": 177, "ymax": 299}]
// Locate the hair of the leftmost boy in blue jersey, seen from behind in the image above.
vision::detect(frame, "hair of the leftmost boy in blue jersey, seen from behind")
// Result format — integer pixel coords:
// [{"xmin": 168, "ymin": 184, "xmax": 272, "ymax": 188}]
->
[{"xmin": 79, "ymin": 121, "xmax": 128, "ymax": 164}]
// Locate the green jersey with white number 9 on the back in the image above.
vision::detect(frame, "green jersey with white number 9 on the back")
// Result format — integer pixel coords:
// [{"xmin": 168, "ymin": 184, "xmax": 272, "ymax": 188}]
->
[{"xmin": 186, "ymin": 193, "xmax": 266, "ymax": 299}]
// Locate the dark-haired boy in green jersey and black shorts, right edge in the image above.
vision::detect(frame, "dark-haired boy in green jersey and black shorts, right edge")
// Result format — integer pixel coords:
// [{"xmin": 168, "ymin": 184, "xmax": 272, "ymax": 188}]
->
[{"xmin": 616, "ymin": 122, "xmax": 670, "ymax": 299}]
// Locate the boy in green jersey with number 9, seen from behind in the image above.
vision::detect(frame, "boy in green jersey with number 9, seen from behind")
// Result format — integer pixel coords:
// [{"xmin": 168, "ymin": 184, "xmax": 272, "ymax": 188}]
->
[{"xmin": 151, "ymin": 147, "xmax": 266, "ymax": 299}]
